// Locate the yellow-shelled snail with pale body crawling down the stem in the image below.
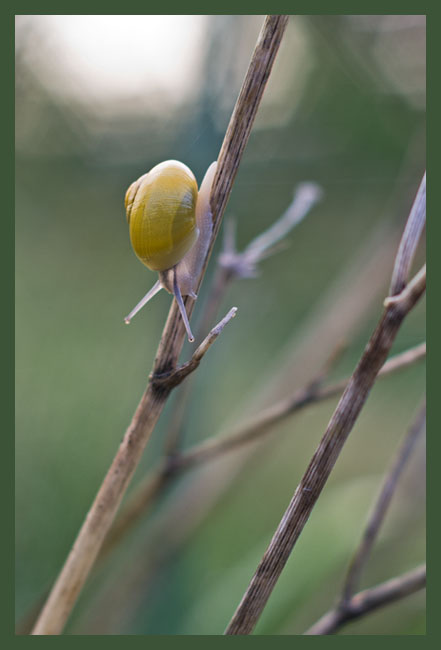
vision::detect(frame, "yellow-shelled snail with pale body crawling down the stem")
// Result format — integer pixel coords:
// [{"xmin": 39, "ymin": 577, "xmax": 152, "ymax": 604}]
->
[{"xmin": 124, "ymin": 160, "xmax": 217, "ymax": 341}]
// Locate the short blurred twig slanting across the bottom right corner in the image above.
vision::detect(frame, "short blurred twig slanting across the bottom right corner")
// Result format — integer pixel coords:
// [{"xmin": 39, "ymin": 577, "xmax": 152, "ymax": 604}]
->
[{"xmin": 305, "ymin": 564, "xmax": 426, "ymax": 635}]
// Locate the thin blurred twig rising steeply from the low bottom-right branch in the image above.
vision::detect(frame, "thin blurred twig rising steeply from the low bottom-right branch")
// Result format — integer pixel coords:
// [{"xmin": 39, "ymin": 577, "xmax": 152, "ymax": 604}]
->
[{"xmin": 338, "ymin": 403, "xmax": 426, "ymax": 610}]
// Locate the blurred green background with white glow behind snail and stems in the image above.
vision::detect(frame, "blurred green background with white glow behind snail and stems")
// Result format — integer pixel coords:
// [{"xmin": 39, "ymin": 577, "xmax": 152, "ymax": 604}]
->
[{"xmin": 16, "ymin": 15, "xmax": 425, "ymax": 635}]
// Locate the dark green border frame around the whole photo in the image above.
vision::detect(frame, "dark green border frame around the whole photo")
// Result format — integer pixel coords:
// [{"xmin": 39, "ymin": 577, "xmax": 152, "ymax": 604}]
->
[{"xmin": 7, "ymin": 0, "xmax": 430, "ymax": 649}]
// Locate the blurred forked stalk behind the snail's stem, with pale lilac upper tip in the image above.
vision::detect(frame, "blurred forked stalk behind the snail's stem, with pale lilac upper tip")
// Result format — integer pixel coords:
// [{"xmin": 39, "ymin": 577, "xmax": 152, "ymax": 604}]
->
[{"xmin": 17, "ymin": 175, "xmax": 426, "ymax": 634}]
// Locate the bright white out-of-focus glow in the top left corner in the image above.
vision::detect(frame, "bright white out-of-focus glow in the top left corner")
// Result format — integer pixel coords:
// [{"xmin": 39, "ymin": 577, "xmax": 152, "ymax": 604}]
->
[{"xmin": 18, "ymin": 15, "xmax": 206, "ymax": 111}]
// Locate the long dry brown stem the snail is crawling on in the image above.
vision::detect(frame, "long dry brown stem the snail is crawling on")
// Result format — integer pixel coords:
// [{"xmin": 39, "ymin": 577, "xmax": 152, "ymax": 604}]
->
[{"xmin": 32, "ymin": 15, "xmax": 288, "ymax": 635}]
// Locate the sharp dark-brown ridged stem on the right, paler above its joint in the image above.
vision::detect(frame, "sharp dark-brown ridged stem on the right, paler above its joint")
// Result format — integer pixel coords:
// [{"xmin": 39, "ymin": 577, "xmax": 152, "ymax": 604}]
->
[{"xmin": 225, "ymin": 172, "xmax": 425, "ymax": 635}]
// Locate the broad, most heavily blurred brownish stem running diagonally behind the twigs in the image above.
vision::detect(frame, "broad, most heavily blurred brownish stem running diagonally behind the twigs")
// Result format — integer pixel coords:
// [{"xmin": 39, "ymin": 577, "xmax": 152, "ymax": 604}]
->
[{"xmin": 75, "ymin": 191, "xmax": 425, "ymax": 634}]
